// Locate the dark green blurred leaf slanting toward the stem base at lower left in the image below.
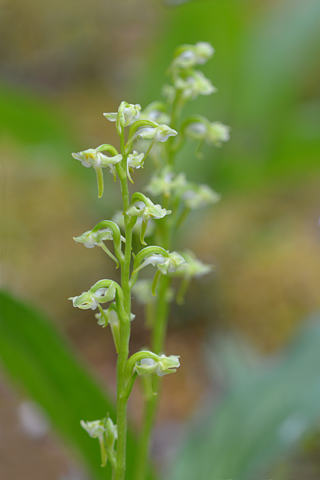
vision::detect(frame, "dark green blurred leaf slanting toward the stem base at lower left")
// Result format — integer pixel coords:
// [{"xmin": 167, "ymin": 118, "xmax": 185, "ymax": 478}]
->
[{"xmin": 0, "ymin": 291, "xmax": 154, "ymax": 480}]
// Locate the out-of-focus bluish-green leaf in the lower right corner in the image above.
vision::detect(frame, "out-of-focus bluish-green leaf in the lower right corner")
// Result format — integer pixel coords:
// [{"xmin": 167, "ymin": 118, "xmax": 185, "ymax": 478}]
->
[{"xmin": 167, "ymin": 316, "xmax": 320, "ymax": 480}]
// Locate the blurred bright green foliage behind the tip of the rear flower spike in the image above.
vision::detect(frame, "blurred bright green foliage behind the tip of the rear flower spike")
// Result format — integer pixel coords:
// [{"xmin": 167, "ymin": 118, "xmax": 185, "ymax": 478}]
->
[{"xmin": 138, "ymin": 0, "xmax": 320, "ymax": 191}]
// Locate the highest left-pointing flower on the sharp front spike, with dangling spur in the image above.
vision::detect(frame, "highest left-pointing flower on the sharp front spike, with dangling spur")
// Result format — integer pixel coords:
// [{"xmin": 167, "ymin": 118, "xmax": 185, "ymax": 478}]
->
[{"xmin": 72, "ymin": 145, "xmax": 122, "ymax": 198}]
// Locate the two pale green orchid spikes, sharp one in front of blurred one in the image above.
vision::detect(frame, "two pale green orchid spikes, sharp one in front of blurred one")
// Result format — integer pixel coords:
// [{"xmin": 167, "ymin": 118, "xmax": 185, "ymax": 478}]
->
[{"xmin": 70, "ymin": 42, "xmax": 230, "ymax": 480}]
